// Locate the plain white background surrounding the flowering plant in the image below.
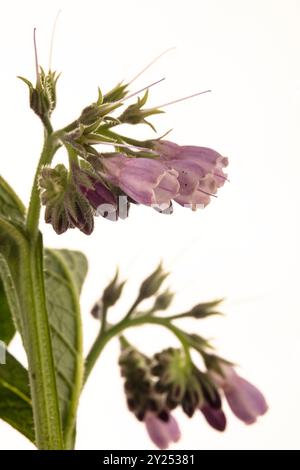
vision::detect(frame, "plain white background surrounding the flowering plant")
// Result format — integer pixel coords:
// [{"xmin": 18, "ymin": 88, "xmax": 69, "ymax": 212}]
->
[{"xmin": 0, "ymin": 0, "xmax": 300, "ymax": 449}]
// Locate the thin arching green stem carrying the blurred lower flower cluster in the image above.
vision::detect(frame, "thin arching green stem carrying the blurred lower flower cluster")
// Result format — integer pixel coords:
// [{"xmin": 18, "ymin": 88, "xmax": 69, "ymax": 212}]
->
[{"xmin": 84, "ymin": 316, "xmax": 191, "ymax": 382}]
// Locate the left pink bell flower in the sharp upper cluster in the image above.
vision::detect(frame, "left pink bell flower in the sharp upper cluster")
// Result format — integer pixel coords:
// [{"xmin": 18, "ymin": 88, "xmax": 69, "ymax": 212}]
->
[{"xmin": 102, "ymin": 154, "xmax": 180, "ymax": 205}]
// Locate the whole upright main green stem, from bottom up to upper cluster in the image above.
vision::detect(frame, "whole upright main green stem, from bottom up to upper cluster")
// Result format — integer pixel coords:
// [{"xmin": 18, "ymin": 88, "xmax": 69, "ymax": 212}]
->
[{"xmin": 20, "ymin": 128, "xmax": 64, "ymax": 450}]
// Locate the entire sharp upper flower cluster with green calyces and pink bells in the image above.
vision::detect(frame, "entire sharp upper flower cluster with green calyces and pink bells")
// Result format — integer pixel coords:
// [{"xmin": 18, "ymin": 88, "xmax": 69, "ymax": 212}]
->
[{"xmin": 22, "ymin": 60, "xmax": 228, "ymax": 234}]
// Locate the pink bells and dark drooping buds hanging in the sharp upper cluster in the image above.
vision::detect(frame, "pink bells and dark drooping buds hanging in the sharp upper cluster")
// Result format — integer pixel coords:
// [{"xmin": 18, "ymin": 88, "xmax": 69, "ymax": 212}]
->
[{"xmin": 40, "ymin": 141, "xmax": 227, "ymax": 234}]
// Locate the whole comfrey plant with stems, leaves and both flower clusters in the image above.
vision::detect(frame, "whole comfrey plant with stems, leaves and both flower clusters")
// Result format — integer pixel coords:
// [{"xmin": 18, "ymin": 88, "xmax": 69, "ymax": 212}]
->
[{"xmin": 0, "ymin": 31, "xmax": 267, "ymax": 449}]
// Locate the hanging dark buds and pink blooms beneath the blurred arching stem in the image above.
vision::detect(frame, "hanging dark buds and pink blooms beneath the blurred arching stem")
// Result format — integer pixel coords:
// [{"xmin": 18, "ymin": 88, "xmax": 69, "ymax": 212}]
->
[{"xmin": 120, "ymin": 345, "xmax": 268, "ymax": 449}]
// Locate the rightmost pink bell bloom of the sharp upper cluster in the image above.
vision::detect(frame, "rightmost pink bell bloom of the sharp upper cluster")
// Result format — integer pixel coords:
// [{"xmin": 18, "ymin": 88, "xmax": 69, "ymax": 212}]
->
[{"xmin": 154, "ymin": 140, "xmax": 228, "ymax": 209}]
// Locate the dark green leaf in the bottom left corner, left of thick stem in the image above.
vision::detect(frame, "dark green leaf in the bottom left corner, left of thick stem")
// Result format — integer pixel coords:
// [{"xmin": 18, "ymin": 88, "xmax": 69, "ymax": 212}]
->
[{"xmin": 0, "ymin": 352, "xmax": 35, "ymax": 442}]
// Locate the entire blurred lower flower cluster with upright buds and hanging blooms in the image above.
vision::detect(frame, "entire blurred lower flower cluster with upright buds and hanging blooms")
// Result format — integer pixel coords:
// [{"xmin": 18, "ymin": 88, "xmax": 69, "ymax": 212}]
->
[{"xmin": 92, "ymin": 265, "xmax": 268, "ymax": 449}]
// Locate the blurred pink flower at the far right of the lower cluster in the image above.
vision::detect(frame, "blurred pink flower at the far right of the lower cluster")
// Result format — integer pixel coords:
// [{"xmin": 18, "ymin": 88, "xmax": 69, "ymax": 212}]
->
[{"xmin": 210, "ymin": 364, "xmax": 268, "ymax": 424}]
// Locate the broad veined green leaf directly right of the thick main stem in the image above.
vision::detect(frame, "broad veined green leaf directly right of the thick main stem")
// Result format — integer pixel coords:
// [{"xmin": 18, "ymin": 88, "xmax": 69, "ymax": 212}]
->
[{"xmin": 45, "ymin": 250, "xmax": 87, "ymax": 446}]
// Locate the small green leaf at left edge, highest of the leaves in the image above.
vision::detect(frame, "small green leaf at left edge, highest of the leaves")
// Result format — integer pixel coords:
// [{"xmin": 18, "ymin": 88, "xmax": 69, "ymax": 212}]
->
[{"xmin": 0, "ymin": 176, "xmax": 25, "ymax": 222}]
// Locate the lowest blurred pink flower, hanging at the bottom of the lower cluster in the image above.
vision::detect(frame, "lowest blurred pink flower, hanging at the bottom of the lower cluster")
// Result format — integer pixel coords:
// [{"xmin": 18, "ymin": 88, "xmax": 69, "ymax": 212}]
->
[{"xmin": 144, "ymin": 411, "xmax": 180, "ymax": 449}]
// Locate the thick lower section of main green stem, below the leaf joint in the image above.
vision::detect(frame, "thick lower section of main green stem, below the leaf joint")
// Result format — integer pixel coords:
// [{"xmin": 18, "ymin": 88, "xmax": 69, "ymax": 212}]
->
[{"xmin": 21, "ymin": 238, "xmax": 64, "ymax": 450}]
